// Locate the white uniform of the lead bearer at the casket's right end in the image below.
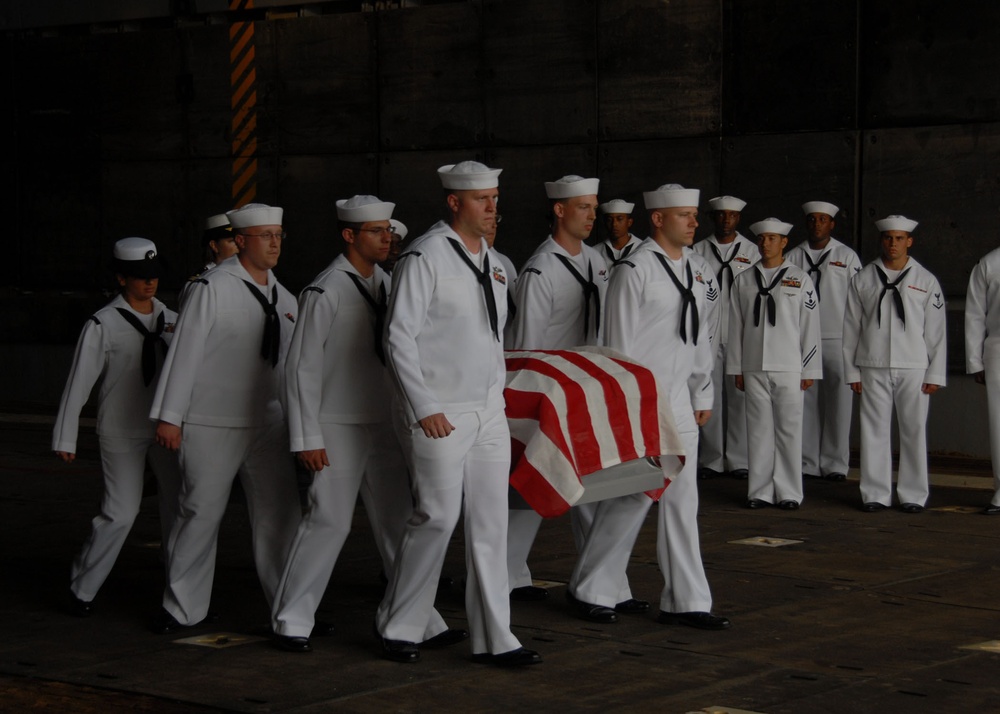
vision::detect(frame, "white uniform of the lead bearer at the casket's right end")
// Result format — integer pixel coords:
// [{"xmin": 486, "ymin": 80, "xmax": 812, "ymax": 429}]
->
[{"xmin": 569, "ymin": 239, "xmax": 718, "ymax": 612}]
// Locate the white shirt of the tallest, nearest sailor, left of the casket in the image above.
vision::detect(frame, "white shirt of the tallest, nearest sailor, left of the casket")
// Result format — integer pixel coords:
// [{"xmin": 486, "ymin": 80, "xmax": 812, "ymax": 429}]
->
[{"xmin": 385, "ymin": 221, "xmax": 508, "ymax": 424}]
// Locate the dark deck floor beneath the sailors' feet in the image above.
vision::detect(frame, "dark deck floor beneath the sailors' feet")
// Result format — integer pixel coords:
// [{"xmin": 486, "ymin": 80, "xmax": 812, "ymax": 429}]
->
[{"xmin": 0, "ymin": 420, "xmax": 1000, "ymax": 714}]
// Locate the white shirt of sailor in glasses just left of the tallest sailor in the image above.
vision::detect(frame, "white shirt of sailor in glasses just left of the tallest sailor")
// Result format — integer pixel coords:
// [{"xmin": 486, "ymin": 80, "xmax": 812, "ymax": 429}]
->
[{"xmin": 285, "ymin": 255, "xmax": 390, "ymax": 452}]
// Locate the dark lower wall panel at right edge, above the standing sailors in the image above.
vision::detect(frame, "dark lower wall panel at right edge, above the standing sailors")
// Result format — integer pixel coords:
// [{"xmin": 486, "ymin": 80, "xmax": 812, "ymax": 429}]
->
[{"xmin": 861, "ymin": 123, "xmax": 1000, "ymax": 296}]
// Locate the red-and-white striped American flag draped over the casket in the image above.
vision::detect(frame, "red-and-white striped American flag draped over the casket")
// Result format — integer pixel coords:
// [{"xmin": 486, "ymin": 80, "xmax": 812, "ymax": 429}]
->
[{"xmin": 504, "ymin": 347, "xmax": 684, "ymax": 517}]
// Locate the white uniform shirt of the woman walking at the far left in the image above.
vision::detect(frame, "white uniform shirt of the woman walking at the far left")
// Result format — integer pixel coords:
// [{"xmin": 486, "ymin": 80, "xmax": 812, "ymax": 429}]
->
[{"xmin": 52, "ymin": 295, "xmax": 177, "ymax": 454}]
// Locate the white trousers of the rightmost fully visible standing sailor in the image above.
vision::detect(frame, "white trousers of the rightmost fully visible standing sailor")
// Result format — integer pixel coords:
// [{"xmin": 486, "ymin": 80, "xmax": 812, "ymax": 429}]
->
[{"xmin": 861, "ymin": 367, "xmax": 930, "ymax": 506}]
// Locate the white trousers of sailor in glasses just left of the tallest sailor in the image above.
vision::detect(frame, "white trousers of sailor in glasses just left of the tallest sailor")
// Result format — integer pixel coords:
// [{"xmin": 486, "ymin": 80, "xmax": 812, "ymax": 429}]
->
[{"xmin": 272, "ymin": 423, "xmax": 447, "ymax": 637}]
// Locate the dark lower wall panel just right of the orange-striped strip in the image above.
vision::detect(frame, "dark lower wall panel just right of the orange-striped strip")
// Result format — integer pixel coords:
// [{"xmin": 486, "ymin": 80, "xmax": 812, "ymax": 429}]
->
[{"xmin": 275, "ymin": 154, "xmax": 378, "ymax": 294}]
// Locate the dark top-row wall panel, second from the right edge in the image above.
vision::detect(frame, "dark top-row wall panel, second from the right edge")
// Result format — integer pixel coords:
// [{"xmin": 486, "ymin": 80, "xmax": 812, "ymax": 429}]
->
[{"xmin": 722, "ymin": 0, "xmax": 857, "ymax": 134}]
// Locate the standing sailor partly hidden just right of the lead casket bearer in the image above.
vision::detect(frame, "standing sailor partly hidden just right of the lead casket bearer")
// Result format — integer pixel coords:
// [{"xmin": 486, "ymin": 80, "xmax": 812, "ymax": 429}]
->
[{"xmin": 694, "ymin": 196, "xmax": 760, "ymax": 479}]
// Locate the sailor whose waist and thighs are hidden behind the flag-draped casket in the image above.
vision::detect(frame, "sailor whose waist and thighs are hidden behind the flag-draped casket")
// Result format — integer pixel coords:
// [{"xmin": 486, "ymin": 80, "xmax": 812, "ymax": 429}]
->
[{"xmin": 507, "ymin": 175, "xmax": 604, "ymax": 608}]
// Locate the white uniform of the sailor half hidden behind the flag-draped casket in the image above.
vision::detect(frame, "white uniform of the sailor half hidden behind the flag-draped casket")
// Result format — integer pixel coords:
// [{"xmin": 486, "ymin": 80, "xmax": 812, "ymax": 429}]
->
[{"xmin": 507, "ymin": 236, "xmax": 609, "ymax": 590}]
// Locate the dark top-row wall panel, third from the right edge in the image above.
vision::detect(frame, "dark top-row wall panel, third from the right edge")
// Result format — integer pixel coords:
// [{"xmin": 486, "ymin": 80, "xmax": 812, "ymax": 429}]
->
[{"xmin": 597, "ymin": 0, "xmax": 722, "ymax": 140}]
